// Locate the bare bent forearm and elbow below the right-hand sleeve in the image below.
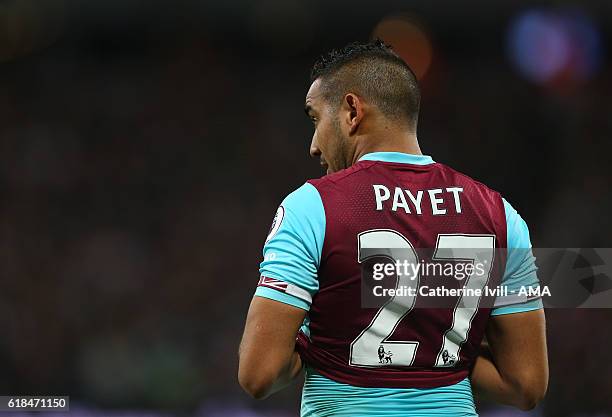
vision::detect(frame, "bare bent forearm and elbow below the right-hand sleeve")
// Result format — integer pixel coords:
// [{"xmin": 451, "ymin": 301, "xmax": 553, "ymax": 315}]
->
[{"xmin": 471, "ymin": 309, "xmax": 548, "ymax": 410}]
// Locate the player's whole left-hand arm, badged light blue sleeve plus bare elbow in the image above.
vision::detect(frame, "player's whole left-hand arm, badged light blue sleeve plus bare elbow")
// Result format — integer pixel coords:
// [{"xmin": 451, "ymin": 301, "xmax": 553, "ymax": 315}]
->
[{"xmin": 238, "ymin": 184, "xmax": 325, "ymax": 398}]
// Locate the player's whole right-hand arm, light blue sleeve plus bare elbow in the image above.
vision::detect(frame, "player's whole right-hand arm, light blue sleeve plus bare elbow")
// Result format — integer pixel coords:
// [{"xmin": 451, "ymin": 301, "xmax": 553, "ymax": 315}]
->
[{"xmin": 471, "ymin": 200, "xmax": 548, "ymax": 410}]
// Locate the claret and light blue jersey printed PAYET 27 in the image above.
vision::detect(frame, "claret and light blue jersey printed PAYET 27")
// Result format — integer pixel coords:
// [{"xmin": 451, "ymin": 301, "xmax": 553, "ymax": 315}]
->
[{"xmin": 255, "ymin": 152, "xmax": 542, "ymax": 417}]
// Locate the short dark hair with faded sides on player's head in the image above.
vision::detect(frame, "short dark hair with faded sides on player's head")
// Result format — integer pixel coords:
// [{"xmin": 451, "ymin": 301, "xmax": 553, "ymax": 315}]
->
[{"xmin": 310, "ymin": 39, "xmax": 421, "ymax": 129}]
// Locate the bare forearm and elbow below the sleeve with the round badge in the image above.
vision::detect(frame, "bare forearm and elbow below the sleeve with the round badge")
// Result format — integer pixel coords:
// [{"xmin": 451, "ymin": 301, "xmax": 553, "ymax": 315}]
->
[{"xmin": 238, "ymin": 297, "xmax": 306, "ymax": 399}]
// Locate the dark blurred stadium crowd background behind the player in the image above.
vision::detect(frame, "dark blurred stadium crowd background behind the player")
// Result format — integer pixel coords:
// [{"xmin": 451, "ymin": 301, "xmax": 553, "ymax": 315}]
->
[{"xmin": 0, "ymin": 0, "xmax": 612, "ymax": 417}]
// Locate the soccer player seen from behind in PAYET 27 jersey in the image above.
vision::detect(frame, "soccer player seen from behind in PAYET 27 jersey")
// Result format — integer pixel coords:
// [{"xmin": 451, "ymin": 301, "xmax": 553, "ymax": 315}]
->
[{"xmin": 238, "ymin": 41, "xmax": 548, "ymax": 417}]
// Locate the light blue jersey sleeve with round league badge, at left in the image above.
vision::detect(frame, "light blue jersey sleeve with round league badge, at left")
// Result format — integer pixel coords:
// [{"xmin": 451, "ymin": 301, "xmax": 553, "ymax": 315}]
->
[{"xmin": 255, "ymin": 183, "xmax": 325, "ymax": 311}]
